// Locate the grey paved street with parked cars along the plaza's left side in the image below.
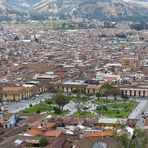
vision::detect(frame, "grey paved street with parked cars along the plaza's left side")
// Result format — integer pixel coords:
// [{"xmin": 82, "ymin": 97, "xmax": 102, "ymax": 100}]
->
[{"xmin": 4, "ymin": 93, "xmax": 54, "ymax": 113}]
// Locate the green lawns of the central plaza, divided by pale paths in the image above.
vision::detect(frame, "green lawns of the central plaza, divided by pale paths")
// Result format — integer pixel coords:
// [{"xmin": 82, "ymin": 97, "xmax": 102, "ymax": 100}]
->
[{"xmin": 22, "ymin": 95, "xmax": 138, "ymax": 118}]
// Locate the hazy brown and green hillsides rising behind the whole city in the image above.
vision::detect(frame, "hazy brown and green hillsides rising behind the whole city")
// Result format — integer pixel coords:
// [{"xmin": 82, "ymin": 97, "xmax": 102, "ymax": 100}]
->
[{"xmin": 0, "ymin": 0, "xmax": 148, "ymax": 21}]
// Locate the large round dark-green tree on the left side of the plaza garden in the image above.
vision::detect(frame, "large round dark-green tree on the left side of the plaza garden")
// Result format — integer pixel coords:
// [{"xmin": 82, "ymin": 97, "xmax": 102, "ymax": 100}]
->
[{"xmin": 54, "ymin": 94, "xmax": 69, "ymax": 110}]
